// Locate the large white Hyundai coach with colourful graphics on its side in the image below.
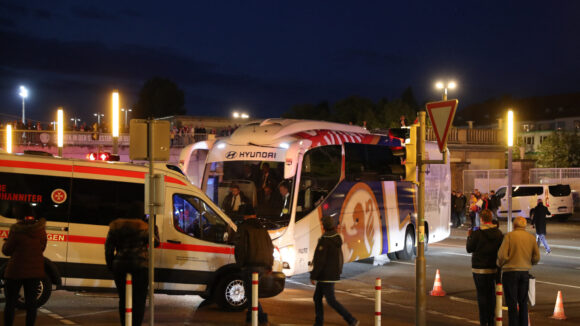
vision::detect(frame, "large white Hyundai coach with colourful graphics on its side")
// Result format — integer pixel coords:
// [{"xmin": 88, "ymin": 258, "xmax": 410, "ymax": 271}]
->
[{"xmin": 180, "ymin": 119, "xmax": 451, "ymax": 276}]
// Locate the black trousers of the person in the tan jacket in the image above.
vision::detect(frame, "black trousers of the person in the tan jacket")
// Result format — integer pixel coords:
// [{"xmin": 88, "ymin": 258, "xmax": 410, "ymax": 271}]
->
[{"xmin": 503, "ymin": 271, "xmax": 530, "ymax": 326}]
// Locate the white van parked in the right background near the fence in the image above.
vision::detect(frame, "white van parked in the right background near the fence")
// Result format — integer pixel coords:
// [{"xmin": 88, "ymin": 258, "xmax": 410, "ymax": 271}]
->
[{"xmin": 496, "ymin": 184, "xmax": 574, "ymax": 220}]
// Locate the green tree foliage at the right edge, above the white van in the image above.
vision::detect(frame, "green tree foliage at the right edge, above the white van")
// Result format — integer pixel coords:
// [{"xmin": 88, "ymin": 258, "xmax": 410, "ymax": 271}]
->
[{"xmin": 537, "ymin": 131, "xmax": 580, "ymax": 168}]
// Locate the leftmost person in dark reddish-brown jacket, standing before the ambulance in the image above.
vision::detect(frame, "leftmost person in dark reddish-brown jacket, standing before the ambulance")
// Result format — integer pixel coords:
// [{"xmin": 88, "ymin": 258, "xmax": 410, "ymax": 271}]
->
[{"xmin": 2, "ymin": 204, "xmax": 47, "ymax": 326}]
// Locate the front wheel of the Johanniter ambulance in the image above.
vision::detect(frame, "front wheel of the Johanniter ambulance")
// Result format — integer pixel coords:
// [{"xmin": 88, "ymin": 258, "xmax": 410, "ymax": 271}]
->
[{"xmin": 214, "ymin": 273, "xmax": 248, "ymax": 311}]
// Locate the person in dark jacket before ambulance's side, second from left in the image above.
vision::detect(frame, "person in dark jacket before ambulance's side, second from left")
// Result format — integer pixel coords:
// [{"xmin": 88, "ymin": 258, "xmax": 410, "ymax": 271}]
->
[{"xmin": 105, "ymin": 214, "xmax": 159, "ymax": 326}]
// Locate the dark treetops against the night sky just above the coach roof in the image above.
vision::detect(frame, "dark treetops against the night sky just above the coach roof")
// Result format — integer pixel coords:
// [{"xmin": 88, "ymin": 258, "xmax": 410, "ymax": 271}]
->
[{"xmin": 282, "ymin": 87, "xmax": 418, "ymax": 129}]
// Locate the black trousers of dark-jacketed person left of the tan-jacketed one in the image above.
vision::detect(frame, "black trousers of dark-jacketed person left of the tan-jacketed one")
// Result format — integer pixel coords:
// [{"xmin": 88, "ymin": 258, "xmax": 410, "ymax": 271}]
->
[{"xmin": 473, "ymin": 273, "xmax": 496, "ymax": 326}]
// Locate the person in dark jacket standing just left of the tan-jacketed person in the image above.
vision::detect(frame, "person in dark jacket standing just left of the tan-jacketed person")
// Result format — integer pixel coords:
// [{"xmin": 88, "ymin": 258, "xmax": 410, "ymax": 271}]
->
[{"xmin": 465, "ymin": 209, "xmax": 503, "ymax": 326}]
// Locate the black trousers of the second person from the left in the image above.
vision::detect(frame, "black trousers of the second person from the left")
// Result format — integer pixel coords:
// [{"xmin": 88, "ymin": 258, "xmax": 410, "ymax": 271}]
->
[{"xmin": 113, "ymin": 268, "xmax": 149, "ymax": 326}]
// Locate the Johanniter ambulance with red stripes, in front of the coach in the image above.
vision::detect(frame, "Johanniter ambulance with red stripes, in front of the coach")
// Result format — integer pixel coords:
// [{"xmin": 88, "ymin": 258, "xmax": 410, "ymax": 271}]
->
[{"xmin": 0, "ymin": 153, "xmax": 285, "ymax": 310}]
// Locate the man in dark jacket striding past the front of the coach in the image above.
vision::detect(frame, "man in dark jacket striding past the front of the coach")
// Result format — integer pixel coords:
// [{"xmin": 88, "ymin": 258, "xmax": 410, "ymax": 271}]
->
[{"xmin": 310, "ymin": 216, "xmax": 359, "ymax": 326}]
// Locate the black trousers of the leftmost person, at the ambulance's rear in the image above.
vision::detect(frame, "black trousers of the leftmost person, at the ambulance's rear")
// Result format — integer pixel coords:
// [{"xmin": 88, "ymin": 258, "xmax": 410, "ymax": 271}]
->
[{"xmin": 4, "ymin": 278, "xmax": 40, "ymax": 326}]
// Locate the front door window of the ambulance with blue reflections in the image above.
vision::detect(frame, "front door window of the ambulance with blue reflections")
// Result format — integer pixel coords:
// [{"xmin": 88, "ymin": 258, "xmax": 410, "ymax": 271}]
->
[{"xmin": 173, "ymin": 194, "xmax": 229, "ymax": 243}]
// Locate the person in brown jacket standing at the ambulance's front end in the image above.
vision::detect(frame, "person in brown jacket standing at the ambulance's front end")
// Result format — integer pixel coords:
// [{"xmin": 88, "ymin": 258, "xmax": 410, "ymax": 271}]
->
[{"xmin": 234, "ymin": 215, "xmax": 274, "ymax": 326}]
